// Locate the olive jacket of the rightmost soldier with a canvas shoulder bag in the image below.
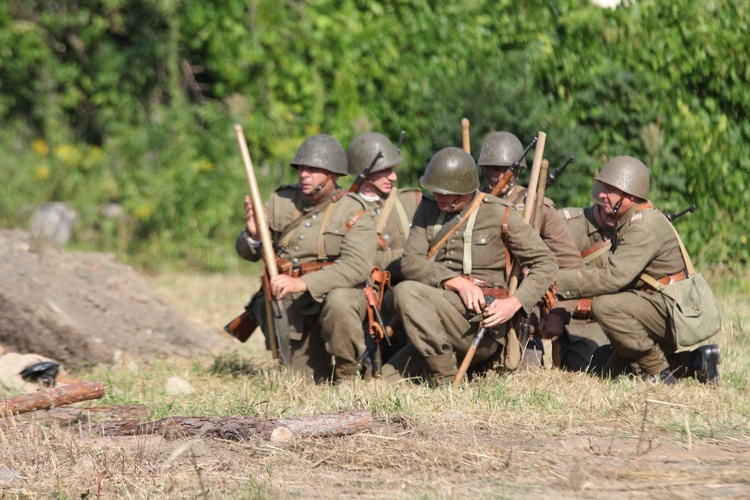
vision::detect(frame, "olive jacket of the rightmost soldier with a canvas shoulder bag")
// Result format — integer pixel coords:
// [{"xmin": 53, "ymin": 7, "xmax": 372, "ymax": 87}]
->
[{"xmin": 557, "ymin": 205, "xmax": 685, "ymax": 298}]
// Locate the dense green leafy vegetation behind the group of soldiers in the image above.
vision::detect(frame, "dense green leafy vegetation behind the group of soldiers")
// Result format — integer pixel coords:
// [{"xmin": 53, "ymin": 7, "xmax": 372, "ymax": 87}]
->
[{"xmin": 0, "ymin": 0, "xmax": 750, "ymax": 271}]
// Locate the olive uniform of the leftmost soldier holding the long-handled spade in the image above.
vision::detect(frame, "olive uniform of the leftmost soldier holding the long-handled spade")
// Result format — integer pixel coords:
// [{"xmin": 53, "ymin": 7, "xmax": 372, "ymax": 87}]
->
[{"xmin": 236, "ymin": 136, "xmax": 376, "ymax": 382}]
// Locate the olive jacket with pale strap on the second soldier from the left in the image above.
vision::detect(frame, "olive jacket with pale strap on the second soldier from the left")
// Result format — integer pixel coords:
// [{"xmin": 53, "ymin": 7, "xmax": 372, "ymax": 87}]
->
[{"xmin": 362, "ymin": 189, "xmax": 422, "ymax": 282}]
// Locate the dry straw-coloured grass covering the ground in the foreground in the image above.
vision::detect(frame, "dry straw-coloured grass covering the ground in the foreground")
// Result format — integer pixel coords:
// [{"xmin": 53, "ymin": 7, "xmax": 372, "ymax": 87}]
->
[{"xmin": 0, "ymin": 275, "xmax": 750, "ymax": 498}]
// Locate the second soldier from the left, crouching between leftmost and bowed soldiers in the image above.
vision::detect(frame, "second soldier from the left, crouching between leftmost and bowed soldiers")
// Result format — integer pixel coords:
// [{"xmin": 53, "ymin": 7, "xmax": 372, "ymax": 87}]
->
[{"xmin": 320, "ymin": 132, "xmax": 422, "ymax": 381}]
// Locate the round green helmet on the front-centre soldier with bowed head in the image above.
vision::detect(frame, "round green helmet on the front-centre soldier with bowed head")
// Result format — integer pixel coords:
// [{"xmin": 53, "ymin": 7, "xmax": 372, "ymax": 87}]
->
[{"xmin": 419, "ymin": 147, "xmax": 479, "ymax": 194}]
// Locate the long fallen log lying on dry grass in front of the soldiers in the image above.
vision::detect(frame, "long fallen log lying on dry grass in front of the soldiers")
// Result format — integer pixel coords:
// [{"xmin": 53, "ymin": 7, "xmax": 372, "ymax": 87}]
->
[{"xmin": 90, "ymin": 411, "xmax": 373, "ymax": 441}]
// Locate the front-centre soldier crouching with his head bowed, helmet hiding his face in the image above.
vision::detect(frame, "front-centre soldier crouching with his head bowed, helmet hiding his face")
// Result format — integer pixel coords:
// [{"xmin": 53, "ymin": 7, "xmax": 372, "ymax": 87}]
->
[{"xmin": 383, "ymin": 148, "xmax": 557, "ymax": 383}]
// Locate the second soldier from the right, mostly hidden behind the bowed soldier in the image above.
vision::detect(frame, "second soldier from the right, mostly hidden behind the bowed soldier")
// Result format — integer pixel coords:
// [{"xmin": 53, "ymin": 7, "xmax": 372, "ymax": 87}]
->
[{"xmin": 477, "ymin": 132, "xmax": 583, "ymax": 364}]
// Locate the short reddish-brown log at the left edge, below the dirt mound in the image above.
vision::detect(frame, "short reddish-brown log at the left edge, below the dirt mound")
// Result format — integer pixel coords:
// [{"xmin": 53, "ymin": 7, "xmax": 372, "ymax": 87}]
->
[{"xmin": 0, "ymin": 382, "xmax": 104, "ymax": 417}]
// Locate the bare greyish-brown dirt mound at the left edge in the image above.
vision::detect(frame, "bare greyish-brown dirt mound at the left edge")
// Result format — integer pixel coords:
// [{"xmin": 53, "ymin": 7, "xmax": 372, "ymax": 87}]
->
[{"xmin": 0, "ymin": 229, "xmax": 214, "ymax": 367}]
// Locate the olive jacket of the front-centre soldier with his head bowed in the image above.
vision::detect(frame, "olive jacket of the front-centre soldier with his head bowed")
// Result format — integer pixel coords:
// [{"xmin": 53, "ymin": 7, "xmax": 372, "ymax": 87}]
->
[{"xmin": 401, "ymin": 194, "xmax": 557, "ymax": 313}]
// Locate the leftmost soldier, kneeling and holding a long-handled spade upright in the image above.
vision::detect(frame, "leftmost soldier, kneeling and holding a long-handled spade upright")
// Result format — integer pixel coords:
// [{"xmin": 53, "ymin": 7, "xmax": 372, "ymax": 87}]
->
[{"xmin": 236, "ymin": 134, "xmax": 376, "ymax": 382}]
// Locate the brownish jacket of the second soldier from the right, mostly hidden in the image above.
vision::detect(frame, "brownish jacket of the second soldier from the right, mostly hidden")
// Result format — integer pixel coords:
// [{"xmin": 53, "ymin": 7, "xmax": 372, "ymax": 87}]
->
[{"xmin": 504, "ymin": 185, "xmax": 583, "ymax": 270}]
